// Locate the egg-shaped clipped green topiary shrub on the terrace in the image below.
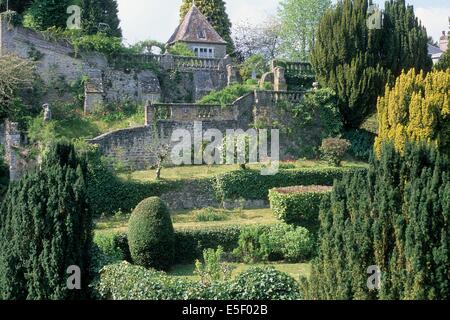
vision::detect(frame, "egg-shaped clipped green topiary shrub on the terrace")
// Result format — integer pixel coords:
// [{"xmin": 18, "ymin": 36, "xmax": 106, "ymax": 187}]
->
[{"xmin": 128, "ymin": 197, "xmax": 175, "ymax": 270}]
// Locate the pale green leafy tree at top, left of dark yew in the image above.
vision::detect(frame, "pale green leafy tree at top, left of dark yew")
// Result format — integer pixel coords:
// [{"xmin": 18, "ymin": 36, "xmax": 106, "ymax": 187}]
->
[{"xmin": 279, "ymin": 0, "xmax": 331, "ymax": 61}]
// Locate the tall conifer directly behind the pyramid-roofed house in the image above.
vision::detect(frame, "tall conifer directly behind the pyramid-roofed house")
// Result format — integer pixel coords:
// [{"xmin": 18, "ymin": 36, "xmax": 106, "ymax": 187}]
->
[{"xmin": 180, "ymin": 0, "xmax": 234, "ymax": 53}]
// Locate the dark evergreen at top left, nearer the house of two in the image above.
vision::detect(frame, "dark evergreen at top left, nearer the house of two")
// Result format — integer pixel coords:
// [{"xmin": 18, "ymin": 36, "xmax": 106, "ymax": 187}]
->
[{"xmin": 81, "ymin": 0, "xmax": 122, "ymax": 38}]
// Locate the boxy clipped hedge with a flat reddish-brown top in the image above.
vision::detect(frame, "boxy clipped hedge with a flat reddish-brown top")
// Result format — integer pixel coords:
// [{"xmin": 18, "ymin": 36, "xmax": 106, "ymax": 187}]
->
[{"xmin": 269, "ymin": 186, "xmax": 332, "ymax": 232}]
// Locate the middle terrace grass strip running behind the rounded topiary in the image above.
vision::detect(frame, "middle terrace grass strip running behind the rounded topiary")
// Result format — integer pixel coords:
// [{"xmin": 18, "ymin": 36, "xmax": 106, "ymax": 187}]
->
[{"xmin": 95, "ymin": 209, "xmax": 278, "ymax": 233}]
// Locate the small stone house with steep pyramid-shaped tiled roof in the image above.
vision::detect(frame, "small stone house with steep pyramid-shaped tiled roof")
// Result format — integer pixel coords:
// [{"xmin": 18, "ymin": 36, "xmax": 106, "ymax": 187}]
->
[{"xmin": 167, "ymin": 5, "xmax": 227, "ymax": 59}]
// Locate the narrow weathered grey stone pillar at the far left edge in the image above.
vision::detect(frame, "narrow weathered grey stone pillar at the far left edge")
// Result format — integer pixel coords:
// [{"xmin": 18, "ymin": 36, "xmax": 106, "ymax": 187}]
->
[{"xmin": 5, "ymin": 121, "xmax": 22, "ymax": 181}]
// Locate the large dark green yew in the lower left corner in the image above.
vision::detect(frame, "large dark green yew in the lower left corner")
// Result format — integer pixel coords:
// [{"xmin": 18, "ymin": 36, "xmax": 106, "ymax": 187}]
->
[{"xmin": 0, "ymin": 144, "xmax": 93, "ymax": 300}]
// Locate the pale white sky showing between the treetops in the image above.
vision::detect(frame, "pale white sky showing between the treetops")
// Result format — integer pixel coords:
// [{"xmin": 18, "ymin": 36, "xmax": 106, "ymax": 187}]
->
[{"xmin": 118, "ymin": 0, "xmax": 450, "ymax": 44}]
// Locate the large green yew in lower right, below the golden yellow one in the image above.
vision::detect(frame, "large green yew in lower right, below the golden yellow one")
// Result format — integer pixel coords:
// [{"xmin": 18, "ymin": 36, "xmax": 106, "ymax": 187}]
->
[{"xmin": 305, "ymin": 145, "xmax": 450, "ymax": 300}]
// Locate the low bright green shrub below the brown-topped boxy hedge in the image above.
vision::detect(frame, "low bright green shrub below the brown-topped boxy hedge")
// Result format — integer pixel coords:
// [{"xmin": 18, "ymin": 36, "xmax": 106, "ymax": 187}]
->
[{"xmin": 233, "ymin": 224, "xmax": 314, "ymax": 263}]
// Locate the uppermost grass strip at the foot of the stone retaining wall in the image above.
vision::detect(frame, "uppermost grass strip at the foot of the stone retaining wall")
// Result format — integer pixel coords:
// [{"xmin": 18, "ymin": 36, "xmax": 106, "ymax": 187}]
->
[{"xmin": 121, "ymin": 160, "xmax": 367, "ymax": 181}]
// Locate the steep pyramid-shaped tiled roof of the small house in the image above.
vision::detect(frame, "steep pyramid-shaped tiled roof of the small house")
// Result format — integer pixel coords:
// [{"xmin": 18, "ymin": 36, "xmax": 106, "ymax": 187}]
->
[{"xmin": 167, "ymin": 5, "xmax": 227, "ymax": 44}]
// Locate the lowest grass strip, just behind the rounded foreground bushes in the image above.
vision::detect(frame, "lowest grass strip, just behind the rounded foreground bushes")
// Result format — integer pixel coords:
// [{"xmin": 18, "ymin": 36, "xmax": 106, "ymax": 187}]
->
[{"xmin": 169, "ymin": 263, "xmax": 311, "ymax": 281}]
